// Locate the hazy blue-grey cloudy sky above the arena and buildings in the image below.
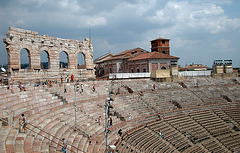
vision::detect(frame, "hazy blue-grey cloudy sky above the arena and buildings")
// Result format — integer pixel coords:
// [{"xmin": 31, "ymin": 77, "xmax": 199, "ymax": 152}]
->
[{"xmin": 0, "ymin": 0, "xmax": 240, "ymax": 67}]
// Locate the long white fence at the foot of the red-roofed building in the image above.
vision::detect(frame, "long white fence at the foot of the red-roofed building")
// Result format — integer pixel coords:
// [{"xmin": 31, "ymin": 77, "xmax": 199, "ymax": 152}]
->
[{"xmin": 109, "ymin": 73, "xmax": 150, "ymax": 79}]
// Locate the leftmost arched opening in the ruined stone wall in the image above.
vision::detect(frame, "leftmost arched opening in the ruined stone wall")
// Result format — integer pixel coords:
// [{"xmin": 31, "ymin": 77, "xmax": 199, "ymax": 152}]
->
[{"xmin": 20, "ymin": 48, "xmax": 30, "ymax": 69}]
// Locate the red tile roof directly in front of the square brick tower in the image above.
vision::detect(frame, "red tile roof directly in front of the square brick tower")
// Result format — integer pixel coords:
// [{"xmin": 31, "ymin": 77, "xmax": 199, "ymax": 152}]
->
[{"xmin": 129, "ymin": 52, "xmax": 179, "ymax": 61}]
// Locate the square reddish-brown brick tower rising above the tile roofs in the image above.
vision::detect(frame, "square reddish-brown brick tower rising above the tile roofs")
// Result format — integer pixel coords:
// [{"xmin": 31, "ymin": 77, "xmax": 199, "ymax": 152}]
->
[{"xmin": 151, "ymin": 38, "xmax": 170, "ymax": 55}]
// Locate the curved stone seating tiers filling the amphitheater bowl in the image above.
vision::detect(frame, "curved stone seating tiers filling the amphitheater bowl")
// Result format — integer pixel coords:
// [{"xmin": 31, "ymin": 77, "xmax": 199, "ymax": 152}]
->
[{"xmin": 0, "ymin": 79, "xmax": 239, "ymax": 152}]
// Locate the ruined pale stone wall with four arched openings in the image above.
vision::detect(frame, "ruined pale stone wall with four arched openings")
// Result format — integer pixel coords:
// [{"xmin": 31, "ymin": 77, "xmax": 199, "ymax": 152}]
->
[{"xmin": 3, "ymin": 27, "xmax": 95, "ymax": 81}]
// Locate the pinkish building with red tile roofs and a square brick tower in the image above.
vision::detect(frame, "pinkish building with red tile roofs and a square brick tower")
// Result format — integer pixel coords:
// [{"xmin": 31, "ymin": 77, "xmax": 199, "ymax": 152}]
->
[{"xmin": 96, "ymin": 38, "xmax": 179, "ymax": 77}]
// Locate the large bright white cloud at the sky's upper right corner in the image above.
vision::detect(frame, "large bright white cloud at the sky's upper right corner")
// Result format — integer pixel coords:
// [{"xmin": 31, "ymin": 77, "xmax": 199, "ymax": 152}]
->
[{"xmin": 148, "ymin": 1, "xmax": 240, "ymax": 34}]
